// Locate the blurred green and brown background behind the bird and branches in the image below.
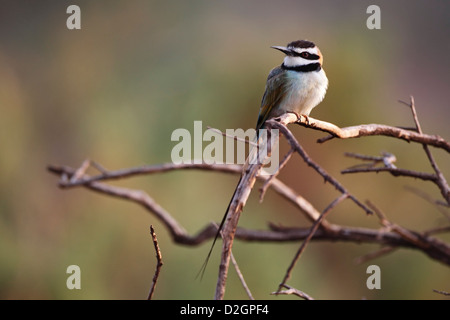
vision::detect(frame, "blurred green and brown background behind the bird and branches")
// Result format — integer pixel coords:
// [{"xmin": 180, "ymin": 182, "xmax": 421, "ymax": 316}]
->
[{"xmin": 0, "ymin": 0, "xmax": 450, "ymax": 299}]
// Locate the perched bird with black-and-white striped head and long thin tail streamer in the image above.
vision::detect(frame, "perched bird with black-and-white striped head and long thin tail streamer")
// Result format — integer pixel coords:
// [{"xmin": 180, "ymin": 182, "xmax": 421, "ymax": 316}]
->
[{"xmin": 201, "ymin": 40, "xmax": 328, "ymax": 275}]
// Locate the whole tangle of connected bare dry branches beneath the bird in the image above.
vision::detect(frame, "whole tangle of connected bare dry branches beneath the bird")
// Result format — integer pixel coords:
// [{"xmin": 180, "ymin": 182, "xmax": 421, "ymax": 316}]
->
[{"xmin": 48, "ymin": 100, "xmax": 450, "ymax": 299}]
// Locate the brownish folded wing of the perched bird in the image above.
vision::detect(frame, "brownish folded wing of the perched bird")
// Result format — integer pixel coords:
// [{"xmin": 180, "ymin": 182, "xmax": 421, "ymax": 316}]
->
[{"xmin": 256, "ymin": 67, "xmax": 286, "ymax": 133}]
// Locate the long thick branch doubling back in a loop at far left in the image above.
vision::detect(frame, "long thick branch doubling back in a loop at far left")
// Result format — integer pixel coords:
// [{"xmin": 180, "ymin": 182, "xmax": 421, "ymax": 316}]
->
[{"xmin": 48, "ymin": 164, "xmax": 450, "ymax": 266}]
